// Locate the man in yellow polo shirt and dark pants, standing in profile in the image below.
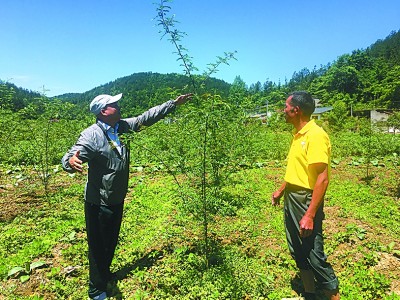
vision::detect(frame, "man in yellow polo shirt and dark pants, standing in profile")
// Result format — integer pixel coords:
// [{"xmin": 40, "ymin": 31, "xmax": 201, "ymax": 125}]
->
[{"xmin": 272, "ymin": 91, "xmax": 340, "ymax": 300}]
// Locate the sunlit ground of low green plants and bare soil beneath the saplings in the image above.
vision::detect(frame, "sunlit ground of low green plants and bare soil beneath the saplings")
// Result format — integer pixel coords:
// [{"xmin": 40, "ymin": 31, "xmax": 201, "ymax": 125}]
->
[{"xmin": 0, "ymin": 156, "xmax": 400, "ymax": 300}]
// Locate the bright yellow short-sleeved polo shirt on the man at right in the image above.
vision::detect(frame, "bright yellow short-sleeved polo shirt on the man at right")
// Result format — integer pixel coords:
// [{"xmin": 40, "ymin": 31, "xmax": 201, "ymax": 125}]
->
[{"xmin": 285, "ymin": 120, "xmax": 331, "ymax": 190}]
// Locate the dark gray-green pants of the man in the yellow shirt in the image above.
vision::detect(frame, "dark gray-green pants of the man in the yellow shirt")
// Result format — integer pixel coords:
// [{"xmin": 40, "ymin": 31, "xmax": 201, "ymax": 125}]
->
[{"xmin": 284, "ymin": 185, "xmax": 339, "ymax": 290}]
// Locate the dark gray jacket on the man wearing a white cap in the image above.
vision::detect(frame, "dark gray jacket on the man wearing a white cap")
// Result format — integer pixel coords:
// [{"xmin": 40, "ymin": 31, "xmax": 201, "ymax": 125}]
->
[{"xmin": 61, "ymin": 100, "xmax": 175, "ymax": 205}]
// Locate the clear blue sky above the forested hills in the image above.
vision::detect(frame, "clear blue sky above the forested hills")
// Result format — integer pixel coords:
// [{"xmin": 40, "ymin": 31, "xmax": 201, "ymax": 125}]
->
[{"xmin": 0, "ymin": 0, "xmax": 400, "ymax": 96}]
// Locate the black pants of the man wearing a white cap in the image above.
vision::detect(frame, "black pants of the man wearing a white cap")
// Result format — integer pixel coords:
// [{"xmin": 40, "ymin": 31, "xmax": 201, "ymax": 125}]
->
[{"xmin": 85, "ymin": 202, "xmax": 124, "ymax": 297}]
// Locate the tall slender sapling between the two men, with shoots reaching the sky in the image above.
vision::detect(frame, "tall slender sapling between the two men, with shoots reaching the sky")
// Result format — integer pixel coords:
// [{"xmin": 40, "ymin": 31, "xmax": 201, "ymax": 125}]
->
[{"xmin": 153, "ymin": 0, "xmax": 241, "ymax": 268}]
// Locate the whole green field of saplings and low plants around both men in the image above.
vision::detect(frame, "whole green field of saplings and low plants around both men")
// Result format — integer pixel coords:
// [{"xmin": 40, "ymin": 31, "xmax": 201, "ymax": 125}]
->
[{"xmin": 0, "ymin": 95, "xmax": 400, "ymax": 300}]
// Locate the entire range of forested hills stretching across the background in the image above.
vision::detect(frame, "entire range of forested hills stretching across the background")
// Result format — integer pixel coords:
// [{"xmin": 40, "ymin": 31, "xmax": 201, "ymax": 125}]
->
[{"xmin": 0, "ymin": 30, "xmax": 400, "ymax": 114}]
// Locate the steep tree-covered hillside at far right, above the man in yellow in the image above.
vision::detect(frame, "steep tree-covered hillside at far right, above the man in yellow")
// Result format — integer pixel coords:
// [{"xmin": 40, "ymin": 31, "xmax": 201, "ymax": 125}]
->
[{"xmin": 286, "ymin": 30, "xmax": 400, "ymax": 108}]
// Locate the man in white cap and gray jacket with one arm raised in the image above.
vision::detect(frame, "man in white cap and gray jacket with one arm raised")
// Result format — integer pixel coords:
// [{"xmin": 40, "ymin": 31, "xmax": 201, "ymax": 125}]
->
[{"xmin": 61, "ymin": 94, "xmax": 192, "ymax": 300}]
